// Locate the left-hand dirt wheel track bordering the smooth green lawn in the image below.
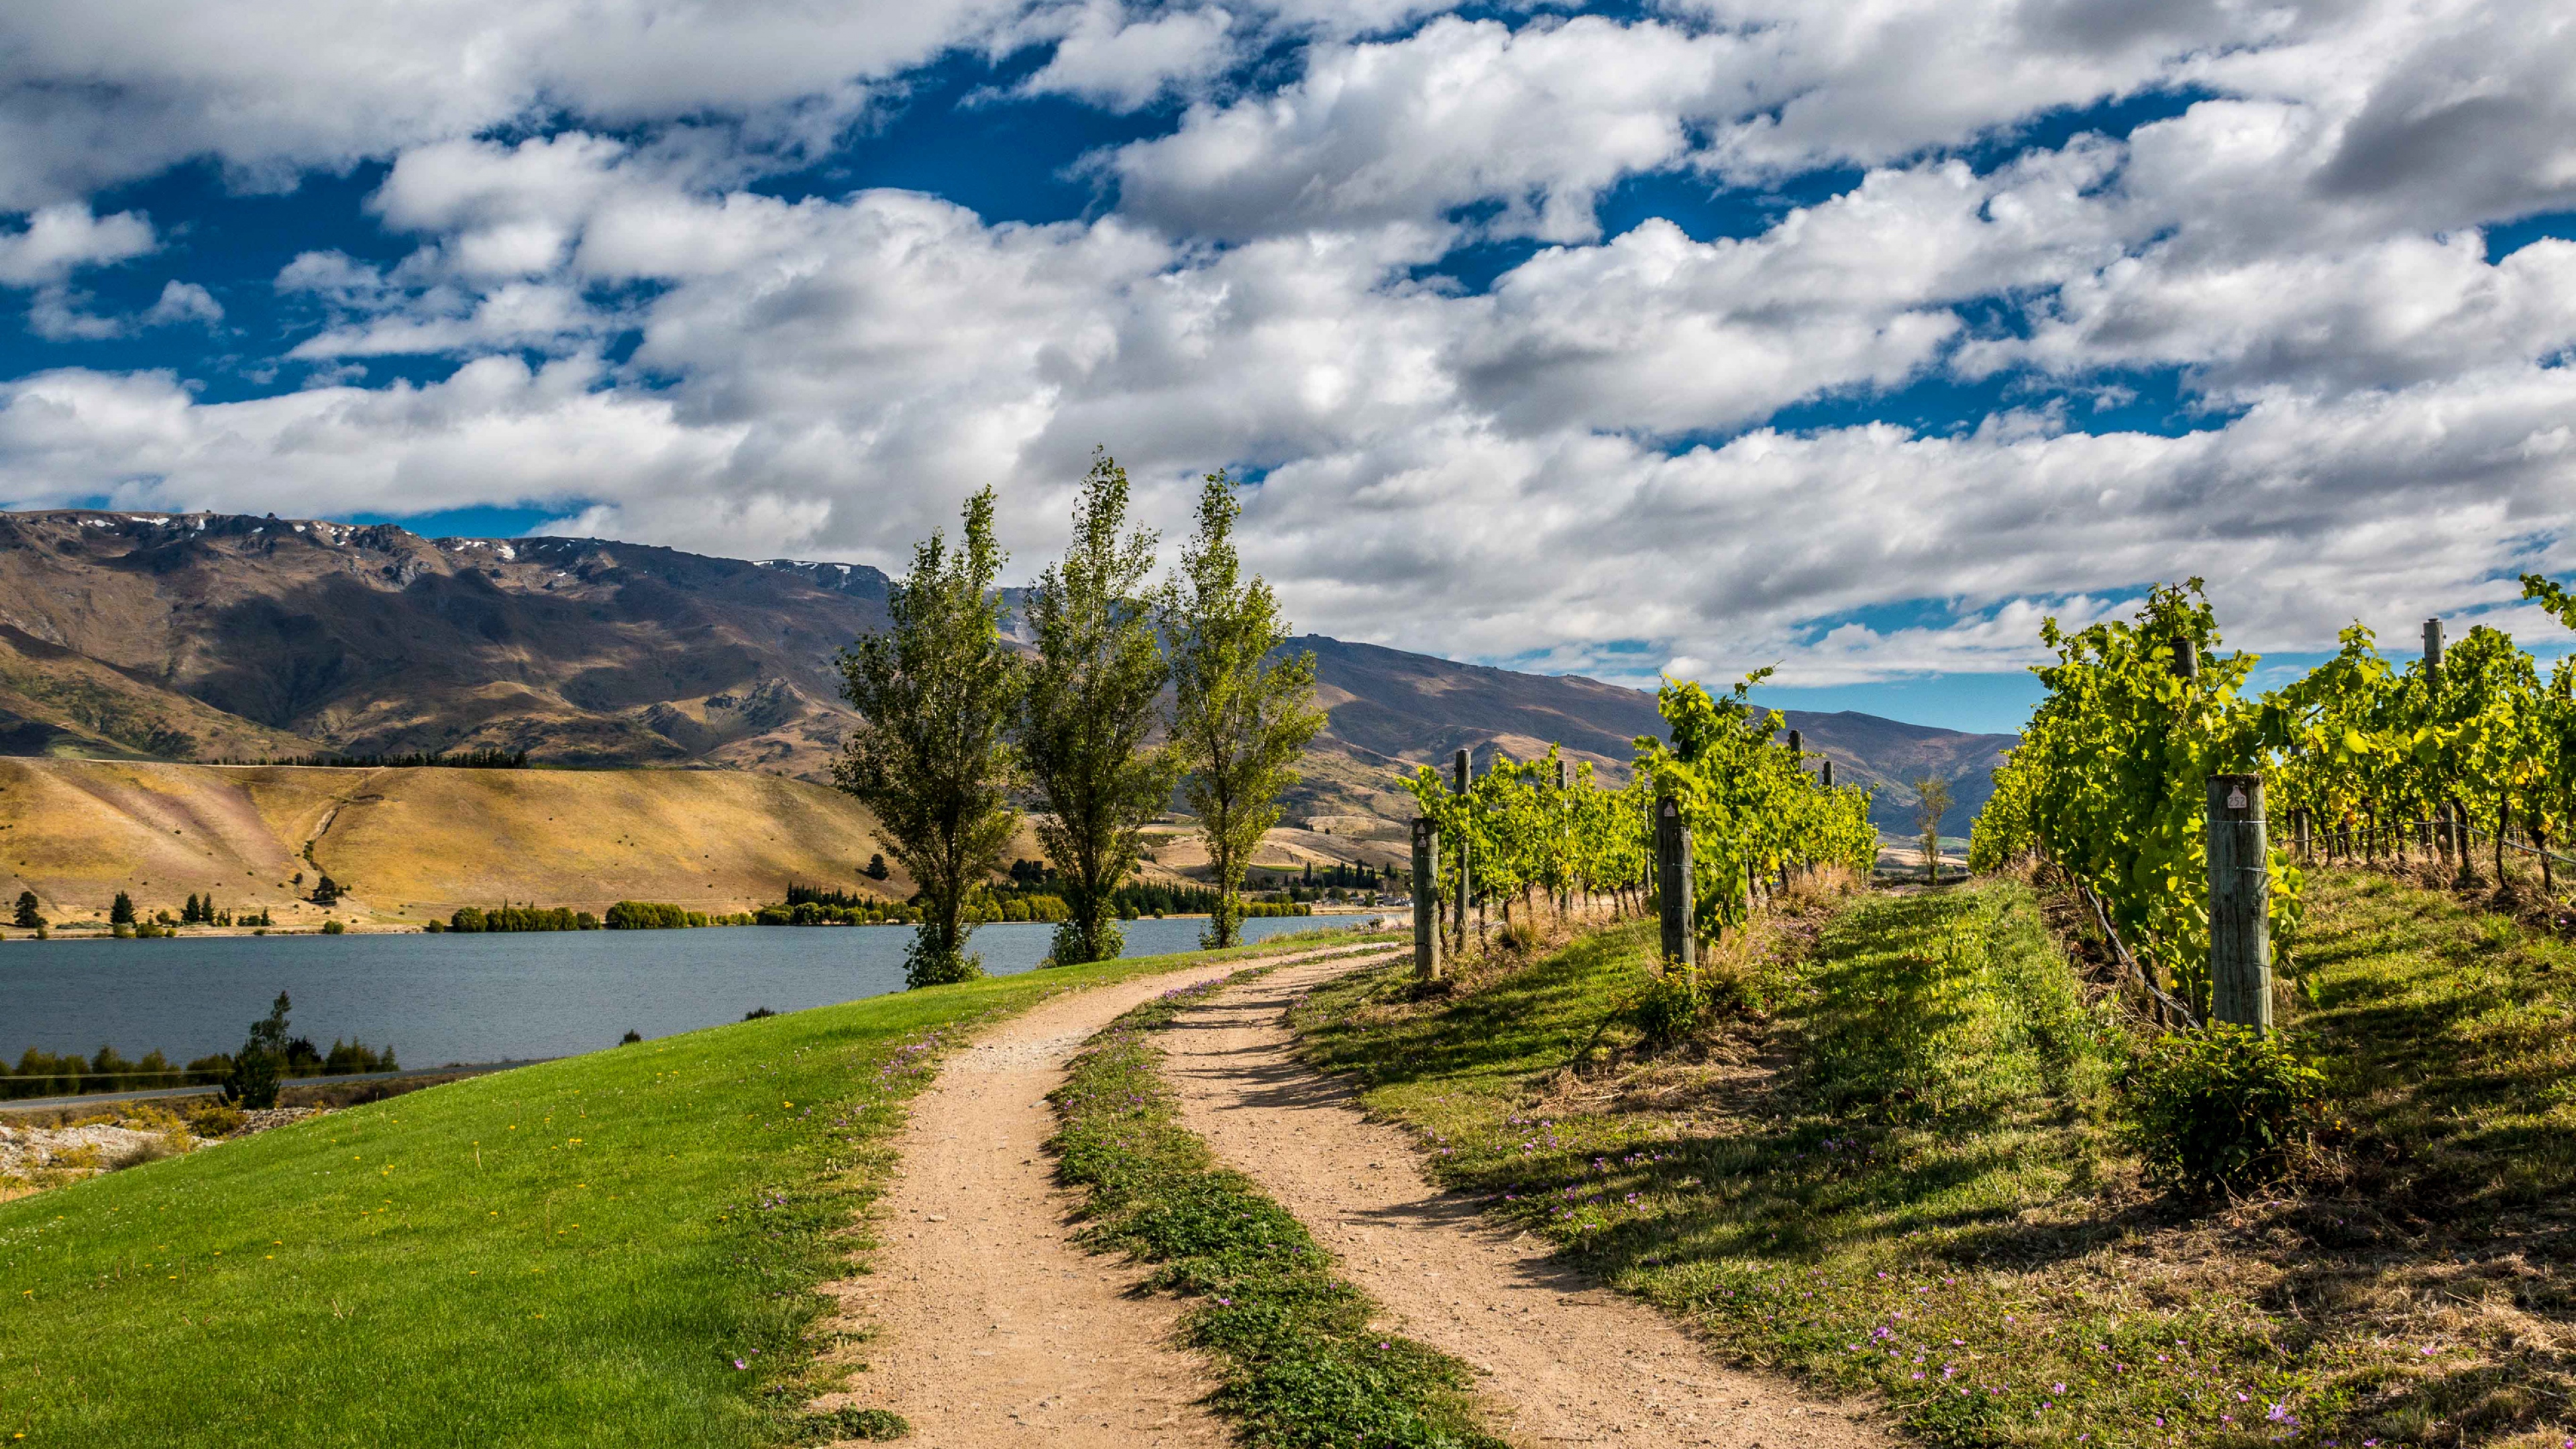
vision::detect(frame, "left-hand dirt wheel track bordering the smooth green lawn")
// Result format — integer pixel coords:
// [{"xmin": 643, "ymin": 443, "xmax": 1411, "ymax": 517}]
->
[{"xmin": 824, "ymin": 947, "xmax": 1391, "ymax": 1449}]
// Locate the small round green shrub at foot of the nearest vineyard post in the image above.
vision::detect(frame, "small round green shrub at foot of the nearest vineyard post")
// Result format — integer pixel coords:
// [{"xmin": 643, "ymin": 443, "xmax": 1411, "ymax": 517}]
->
[{"xmin": 2120, "ymin": 1021, "xmax": 2326, "ymax": 1191}]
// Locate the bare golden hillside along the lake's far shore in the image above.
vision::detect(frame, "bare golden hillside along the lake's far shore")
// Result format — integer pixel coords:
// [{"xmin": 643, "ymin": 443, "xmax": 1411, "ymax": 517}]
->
[{"xmin": 0, "ymin": 758, "xmax": 927, "ymax": 926}]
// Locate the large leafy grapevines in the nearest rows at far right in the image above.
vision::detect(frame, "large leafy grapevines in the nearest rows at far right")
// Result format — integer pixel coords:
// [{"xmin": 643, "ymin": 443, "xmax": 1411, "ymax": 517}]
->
[{"xmin": 1968, "ymin": 575, "xmax": 2576, "ymax": 1024}]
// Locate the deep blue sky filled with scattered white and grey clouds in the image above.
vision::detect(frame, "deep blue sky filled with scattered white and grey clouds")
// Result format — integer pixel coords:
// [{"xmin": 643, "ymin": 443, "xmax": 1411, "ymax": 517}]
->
[{"xmin": 0, "ymin": 0, "xmax": 2576, "ymax": 730}]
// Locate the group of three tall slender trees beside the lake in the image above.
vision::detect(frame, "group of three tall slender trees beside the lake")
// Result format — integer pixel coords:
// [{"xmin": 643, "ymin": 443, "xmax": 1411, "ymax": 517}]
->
[{"xmin": 835, "ymin": 451, "xmax": 1324, "ymax": 985}]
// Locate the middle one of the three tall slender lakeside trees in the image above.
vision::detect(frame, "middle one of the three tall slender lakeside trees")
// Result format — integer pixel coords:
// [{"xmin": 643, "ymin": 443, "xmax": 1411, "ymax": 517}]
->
[{"xmin": 1020, "ymin": 449, "xmax": 1175, "ymax": 967}]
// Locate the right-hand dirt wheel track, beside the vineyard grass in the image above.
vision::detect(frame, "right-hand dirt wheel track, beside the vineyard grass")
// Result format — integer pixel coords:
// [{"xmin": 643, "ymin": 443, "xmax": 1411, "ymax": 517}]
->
[{"xmin": 1165, "ymin": 962, "xmax": 1888, "ymax": 1449}]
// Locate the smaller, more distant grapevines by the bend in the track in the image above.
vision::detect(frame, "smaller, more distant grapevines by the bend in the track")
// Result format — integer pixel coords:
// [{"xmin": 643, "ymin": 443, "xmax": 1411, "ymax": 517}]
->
[{"xmin": 1409, "ymin": 670, "xmax": 1878, "ymax": 938}]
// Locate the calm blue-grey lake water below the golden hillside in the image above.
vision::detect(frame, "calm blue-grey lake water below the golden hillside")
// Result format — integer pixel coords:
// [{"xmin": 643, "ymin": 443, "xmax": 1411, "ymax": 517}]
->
[{"xmin": 0, "ymin": 915, "xmax": 1350, "ymax": 1067}]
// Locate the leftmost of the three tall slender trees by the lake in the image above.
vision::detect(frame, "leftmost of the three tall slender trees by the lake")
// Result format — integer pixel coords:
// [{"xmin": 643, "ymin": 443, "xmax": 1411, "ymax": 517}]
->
[{"xmin": 832, "ymin": 487, "xmax": 1025, "ymax": 987}]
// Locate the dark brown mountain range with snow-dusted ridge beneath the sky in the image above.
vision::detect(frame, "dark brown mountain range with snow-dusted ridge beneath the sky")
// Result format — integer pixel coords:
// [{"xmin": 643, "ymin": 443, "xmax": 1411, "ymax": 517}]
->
[{"xmin": 0, "ymin": 511, "xmax": 2015, "ymax": 833}]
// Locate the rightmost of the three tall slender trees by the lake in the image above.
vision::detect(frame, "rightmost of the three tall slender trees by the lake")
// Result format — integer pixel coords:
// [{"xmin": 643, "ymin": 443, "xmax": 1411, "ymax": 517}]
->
[{"xmin": 1162, "ymin": 470, "xmax": 1324, "ymax": 947}]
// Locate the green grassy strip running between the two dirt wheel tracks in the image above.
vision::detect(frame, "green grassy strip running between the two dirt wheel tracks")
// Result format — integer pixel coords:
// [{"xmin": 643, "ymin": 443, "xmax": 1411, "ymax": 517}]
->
[{"xmin": 1049, "ymin": 982, "xmax": 1502, "ymax": 1449}]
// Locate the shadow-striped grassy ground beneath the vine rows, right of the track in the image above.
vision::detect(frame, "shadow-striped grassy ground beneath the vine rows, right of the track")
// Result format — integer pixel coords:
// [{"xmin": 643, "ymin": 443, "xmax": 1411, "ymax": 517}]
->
[{"xmin": 1301, "ymin": 874, "xmax": 2576, "ymax": 1446}]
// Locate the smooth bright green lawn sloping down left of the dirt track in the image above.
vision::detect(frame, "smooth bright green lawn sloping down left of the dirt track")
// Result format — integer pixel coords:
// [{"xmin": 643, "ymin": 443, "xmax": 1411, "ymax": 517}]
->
[{"xmin": 0, "ymin": 941, "xmax": 1360, "ymax": 1449}]
